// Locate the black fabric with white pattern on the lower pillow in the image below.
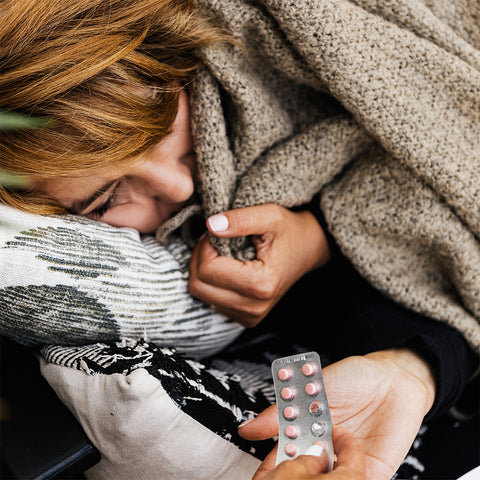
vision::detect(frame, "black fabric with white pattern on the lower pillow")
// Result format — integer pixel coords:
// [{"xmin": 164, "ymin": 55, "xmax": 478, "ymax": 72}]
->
[{"xmin": 42, "ymin": 335, "xmax": 427, "ymax": 480}]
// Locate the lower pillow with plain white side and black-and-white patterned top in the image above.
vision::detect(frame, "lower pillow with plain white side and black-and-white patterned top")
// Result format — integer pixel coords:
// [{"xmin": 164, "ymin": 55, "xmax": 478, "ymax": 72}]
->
[{"xmin": 41, "ymin": 341, "xmax": 274, "ymax": 480}]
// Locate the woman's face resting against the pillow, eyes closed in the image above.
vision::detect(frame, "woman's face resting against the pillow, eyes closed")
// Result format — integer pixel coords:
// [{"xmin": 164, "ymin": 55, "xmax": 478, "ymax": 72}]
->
[{"xmin": 34, "ymin": 92, "xmax": 196, "ymax": 233}]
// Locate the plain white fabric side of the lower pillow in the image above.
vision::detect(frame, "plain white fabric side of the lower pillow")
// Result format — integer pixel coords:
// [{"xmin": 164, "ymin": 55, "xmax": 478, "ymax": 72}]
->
[{"xmin": 41, "ymin": 359, "xmax": 260, "ymax": 480}]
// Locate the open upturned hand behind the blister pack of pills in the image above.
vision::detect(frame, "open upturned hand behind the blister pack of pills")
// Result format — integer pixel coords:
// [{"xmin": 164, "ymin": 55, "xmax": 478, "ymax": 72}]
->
[{"xmin": 239, "ymin": 349, "xmax": 435, "ymax": 480}]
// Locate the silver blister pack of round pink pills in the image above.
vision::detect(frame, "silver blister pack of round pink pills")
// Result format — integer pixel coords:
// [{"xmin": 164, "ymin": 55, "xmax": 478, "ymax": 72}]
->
[{"xmin": 272, "ymin": 352, "xmax": 334, "ymax": 471}]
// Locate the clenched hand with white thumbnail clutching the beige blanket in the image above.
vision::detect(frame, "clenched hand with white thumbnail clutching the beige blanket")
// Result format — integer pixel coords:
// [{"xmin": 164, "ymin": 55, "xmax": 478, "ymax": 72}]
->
[{"xmin": 189, "ymin": 204, "xmax": 330, "ymax": 327}]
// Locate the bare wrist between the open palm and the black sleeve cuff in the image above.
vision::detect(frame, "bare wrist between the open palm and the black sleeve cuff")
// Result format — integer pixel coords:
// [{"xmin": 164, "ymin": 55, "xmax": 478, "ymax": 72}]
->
[{"xmin": 365, "ymin": 348, "xmax": 436, "ymax": 415}]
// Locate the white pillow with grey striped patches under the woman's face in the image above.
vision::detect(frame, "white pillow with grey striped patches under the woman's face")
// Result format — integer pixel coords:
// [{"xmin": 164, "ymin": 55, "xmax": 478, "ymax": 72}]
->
[{"xmin": 0, "ymin": 205, "xmax": 243, "ymax": 358}]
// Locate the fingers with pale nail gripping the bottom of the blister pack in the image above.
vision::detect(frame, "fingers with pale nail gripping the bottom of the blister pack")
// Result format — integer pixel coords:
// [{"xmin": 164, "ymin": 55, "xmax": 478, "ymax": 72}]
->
[{"xmin": 252, "ymin": 427, "xmax": 367, "ymax": 480}]
